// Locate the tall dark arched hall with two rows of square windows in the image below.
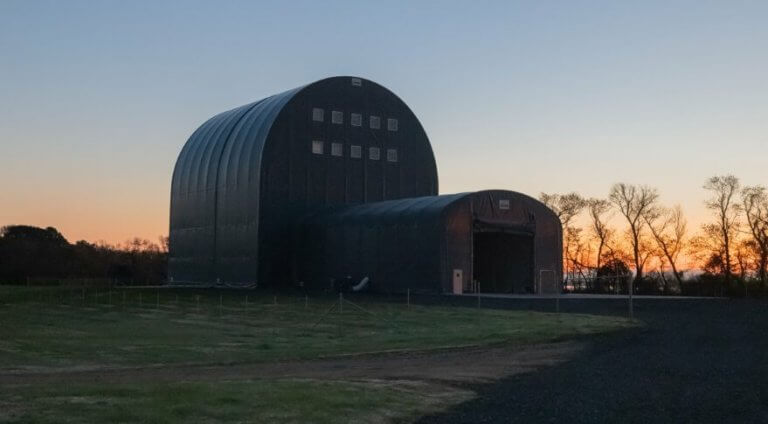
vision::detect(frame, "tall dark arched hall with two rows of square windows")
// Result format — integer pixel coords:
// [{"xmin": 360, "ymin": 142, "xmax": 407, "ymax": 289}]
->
[{"xmin": 169, "ymin": 77, "xmax": 438, "ymax": 286}]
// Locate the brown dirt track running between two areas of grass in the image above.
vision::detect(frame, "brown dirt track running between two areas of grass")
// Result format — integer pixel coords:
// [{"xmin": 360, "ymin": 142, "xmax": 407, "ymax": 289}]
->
[{"xmin": 0, "ymin": 341, "xmax": 585, "ymax": 385}]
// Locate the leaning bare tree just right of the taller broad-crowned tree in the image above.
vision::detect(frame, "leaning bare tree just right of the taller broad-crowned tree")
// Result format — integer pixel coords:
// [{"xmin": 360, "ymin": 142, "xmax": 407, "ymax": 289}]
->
[{"xmin": 644, "ymin": 206, "xmax": 688, "ymax": 289}]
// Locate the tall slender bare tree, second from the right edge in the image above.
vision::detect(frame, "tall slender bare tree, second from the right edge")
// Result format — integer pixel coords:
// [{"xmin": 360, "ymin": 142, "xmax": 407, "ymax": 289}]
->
[{"xmin": 704, "ymin": 175, "xmax": 741, "ymax": 287}]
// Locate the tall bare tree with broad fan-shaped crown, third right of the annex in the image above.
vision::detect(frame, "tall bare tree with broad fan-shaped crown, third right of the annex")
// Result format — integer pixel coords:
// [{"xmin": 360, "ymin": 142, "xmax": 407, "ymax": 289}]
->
[{"xmin": 608, "ymin": 183, "xmax": 659, "ymax": 282}]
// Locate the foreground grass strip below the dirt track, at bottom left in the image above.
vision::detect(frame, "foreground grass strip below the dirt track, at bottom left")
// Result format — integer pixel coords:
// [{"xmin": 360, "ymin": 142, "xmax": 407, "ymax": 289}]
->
[{"xmin": 0, "ymin": 380, "xmax": 471, "ymax": 423}]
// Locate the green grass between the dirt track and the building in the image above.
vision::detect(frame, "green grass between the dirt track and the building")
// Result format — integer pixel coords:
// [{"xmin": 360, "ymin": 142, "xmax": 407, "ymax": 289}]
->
[{"xmin": 0, "ymin": 288, "xmax": 629, "ymax": 370}]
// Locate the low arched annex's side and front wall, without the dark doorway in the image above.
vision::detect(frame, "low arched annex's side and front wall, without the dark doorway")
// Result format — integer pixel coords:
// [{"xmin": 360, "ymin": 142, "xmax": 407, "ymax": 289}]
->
[{"xmin": 297, "ymin": 190, "xmax": 562, "ymax": 293}]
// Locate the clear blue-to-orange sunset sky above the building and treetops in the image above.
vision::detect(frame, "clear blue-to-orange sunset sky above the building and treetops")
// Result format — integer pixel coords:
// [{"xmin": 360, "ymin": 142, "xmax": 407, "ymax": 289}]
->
[{"xmin": 0, "ymin": 0, "xmax": 768, "ymax": 243}]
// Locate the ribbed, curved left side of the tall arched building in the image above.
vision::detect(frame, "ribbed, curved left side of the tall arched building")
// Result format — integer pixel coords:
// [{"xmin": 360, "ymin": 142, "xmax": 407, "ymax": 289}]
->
[{"xmin": 168, "ymin": 87, "xmax": 301, "ymax": 282}]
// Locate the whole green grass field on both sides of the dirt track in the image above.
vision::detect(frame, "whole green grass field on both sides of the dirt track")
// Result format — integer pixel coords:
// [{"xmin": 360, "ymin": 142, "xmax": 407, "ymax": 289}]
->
[{"xmin": 0, "ymin": 287, "xmax": 630, "ymax": 422}]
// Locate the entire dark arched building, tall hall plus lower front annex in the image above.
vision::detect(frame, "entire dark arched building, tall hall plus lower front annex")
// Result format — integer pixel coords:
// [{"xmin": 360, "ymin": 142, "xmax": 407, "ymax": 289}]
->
[{"xmin": 168, "ymin": 77, "xmax": 562, "ymax": 293}]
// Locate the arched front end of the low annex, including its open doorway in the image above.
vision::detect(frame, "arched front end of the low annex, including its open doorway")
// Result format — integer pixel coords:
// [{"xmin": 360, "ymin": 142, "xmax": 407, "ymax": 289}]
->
[{"xmin": 443, "ymin": 190, "xmax": 562, "ymax": 294}]
